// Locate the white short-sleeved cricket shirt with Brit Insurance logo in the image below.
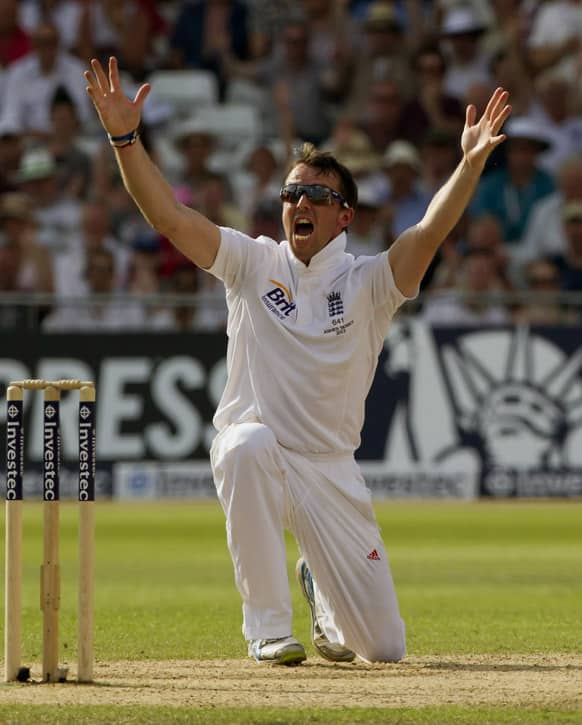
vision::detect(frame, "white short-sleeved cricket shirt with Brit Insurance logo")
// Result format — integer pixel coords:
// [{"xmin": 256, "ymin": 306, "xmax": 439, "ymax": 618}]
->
[{"xmin": 208, "ymin": 228, "xmax": 406, "ymax": 454}]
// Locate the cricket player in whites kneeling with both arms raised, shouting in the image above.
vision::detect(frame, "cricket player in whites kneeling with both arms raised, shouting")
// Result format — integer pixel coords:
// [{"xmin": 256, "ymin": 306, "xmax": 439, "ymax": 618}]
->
[{"xmin": 85, "ymin": 58, "xmax": 510, "ymax": 665}]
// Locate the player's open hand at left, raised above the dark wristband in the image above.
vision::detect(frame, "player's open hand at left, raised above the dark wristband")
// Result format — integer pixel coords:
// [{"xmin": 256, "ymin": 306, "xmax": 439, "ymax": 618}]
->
[{"xmin": 84, "ymin": 57, "xmax": 151, "ymax": 136}]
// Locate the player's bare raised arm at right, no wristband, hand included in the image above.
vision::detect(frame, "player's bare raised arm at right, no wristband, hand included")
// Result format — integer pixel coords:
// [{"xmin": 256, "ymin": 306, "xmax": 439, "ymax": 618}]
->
[{"xmin": 389, "ymin": 88, "xmax": 511, "ymax": 296}]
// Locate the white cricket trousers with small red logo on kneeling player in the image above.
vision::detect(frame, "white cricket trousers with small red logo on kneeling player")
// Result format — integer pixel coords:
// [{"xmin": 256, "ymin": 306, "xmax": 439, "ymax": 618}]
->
[{"xmin": 211, "ymin": 422, "xmax": 405, "ymax": 662}]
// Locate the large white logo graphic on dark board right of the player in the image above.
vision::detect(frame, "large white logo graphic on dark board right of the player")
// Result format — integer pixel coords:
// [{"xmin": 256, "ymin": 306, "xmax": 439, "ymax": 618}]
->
[{"xmin": 376, "ymin": 320, "xmax": 582, "ymax": 495}]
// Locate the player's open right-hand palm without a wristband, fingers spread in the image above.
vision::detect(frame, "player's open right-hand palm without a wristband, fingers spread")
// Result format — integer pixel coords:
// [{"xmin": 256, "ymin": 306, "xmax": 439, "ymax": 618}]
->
[{"xmin": 461, "ymin": 88, "xmax": 511, "ymax": 165}]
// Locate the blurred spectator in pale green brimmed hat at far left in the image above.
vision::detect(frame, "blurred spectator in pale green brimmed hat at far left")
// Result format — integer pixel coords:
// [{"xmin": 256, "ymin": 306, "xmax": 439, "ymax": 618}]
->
[{"xmin": 16, "ymin": 148, "xmax": 81, "ymax": 253}]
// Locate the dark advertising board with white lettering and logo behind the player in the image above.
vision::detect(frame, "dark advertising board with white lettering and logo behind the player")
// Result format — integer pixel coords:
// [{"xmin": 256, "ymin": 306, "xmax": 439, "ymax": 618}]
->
[{"xmin": 0, "ymin": 320, "xmax": 582, "ymax": 498}]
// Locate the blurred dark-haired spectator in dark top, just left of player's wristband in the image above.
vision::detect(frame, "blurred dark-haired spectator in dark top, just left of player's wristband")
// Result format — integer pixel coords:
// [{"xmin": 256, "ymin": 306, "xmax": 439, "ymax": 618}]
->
[{"xmin": 47, "ymin": 86, "xmax": 91, "ymax": 199}]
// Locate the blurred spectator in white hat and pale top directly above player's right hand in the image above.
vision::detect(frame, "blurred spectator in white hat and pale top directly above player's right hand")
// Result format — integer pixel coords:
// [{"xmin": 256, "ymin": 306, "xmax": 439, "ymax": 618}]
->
[{"xmin": 441, "ymin": 5, "xmax": 491, "ymax": 102}]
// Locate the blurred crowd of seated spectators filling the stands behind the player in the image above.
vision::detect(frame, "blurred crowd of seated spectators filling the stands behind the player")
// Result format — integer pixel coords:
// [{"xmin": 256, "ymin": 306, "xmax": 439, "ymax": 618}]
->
[{"xmin": 0, "ymin": 0, "xmax": 582, "ymax": 332}]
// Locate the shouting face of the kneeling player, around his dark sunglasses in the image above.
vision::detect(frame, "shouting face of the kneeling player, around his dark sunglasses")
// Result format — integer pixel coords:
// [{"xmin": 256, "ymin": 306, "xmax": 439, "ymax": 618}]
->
[{"xmin": 283, "ymin": 164, "xmax": 354, "ymax": 264}]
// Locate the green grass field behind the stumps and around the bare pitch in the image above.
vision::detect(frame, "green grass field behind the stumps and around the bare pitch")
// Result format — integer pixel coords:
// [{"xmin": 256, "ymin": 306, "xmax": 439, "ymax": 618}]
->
[{"xmin": 0, "ymin": 501, "xmax": 582, "ymax": 723}]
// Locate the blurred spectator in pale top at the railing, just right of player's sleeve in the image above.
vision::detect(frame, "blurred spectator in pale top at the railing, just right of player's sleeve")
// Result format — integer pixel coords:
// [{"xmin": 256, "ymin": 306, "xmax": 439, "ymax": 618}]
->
[{"xmin": 422, "ymin": 249, "xmax": 510, "ymax": 327}]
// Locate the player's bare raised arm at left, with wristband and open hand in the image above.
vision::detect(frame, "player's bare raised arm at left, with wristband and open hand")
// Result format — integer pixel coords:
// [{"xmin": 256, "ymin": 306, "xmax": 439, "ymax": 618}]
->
[{"xmin": 85, "ymin": 57, "xmax": 220, "ymax": 268}]
